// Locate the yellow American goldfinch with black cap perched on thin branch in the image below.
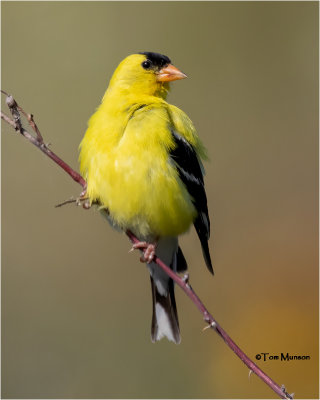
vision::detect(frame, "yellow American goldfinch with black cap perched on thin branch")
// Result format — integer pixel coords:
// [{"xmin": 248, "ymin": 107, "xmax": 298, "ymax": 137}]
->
[{"xmin": 79, "ymin": 52, "xmax": 213, "ymax": 343}]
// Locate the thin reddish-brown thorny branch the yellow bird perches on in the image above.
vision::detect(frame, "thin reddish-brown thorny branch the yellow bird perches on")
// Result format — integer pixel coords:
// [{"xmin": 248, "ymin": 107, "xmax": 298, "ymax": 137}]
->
[{"xmin": 1, "ymin": 91, "xmax": 293, "ymax": 399}]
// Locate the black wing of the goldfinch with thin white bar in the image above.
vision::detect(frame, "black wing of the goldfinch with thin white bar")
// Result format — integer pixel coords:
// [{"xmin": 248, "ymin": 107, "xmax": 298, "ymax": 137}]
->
[{"xmin": 170, "ymin": 130, "xmax": 213, "ymax": 274}]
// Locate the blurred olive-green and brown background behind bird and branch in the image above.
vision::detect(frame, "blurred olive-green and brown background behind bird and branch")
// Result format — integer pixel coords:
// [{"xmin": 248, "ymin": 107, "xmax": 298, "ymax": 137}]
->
[{"xmin": 1, "ymin": 2, "xmax": 319, "ymax": 398}]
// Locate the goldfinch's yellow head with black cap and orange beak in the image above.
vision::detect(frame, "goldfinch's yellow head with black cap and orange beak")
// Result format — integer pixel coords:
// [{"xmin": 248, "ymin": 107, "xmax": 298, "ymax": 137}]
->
[{"xmin": 109, "ymin": 52, "xmax": 187, "ymax": 98}]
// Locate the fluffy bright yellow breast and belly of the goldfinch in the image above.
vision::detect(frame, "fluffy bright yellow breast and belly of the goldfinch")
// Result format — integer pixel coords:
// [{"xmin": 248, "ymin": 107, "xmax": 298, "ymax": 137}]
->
[{"xmin": 80, "ymin": 98, "xmax": 196, "ymax": 236}]
